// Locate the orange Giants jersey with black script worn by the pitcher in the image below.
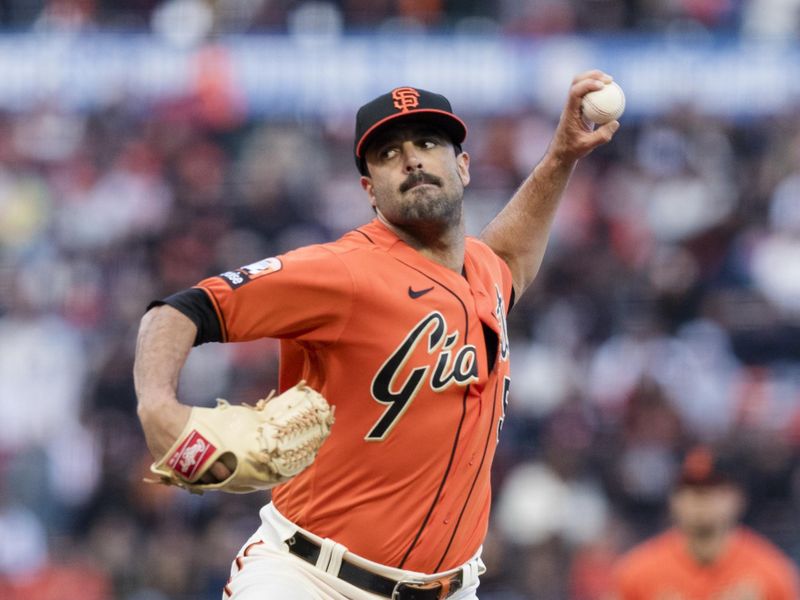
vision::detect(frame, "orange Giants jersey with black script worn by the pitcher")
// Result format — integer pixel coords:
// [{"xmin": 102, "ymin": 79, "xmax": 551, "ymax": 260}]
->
[{"xmin": 192, "ymin": 220, "xmax": 512, "ymax": 573}]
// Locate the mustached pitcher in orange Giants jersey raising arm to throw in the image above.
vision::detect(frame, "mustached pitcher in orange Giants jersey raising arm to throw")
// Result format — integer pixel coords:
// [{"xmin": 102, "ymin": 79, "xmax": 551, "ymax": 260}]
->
[{"xmin": 134, "ymin": 71, "xmax": 619, "ymax": 600}]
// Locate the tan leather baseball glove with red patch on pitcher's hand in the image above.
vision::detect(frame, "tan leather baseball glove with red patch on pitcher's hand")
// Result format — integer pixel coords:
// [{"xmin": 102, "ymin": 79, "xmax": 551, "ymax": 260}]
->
[{"xmin": 150, "ymin": 381, "xmax": 333, "ymax": 494}]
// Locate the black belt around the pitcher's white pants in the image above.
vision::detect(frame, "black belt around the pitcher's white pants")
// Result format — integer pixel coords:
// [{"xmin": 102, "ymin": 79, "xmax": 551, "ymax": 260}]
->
[{"xmin": 286, "ymin": 531, "xmax": 464, "ymax": 600}]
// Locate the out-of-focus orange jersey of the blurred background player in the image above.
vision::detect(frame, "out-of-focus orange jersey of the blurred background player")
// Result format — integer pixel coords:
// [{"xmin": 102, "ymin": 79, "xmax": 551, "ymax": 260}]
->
[{"xmin": 615, "ymin": 528, "xmax": 800, "ymax": 600}]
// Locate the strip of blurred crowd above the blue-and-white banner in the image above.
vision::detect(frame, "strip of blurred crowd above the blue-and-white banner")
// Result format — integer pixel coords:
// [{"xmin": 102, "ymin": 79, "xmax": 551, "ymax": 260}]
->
[{"xmin": 0, "ymin": 0, "xmax": 798, "ymax": 38}]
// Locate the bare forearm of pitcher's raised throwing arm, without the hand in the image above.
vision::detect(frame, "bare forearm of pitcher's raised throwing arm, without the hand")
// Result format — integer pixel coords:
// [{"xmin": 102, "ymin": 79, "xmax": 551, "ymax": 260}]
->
[{"xmin": 481, "ymin": 154, "xmax": 577, "ymax": 298}]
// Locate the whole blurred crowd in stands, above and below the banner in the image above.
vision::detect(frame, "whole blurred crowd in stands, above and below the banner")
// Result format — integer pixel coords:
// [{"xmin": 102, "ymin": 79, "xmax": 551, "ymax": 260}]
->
[{"xmin": 0, "ymin": 0, "xmax": 800, "ymax": 600}]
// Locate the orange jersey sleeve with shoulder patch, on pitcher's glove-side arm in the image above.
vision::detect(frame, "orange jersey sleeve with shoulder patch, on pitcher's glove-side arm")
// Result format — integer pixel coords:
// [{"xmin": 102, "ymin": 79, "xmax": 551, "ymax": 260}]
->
[{"xmin": 196, "ymin": 246, "xmax": 354, "ymax": 343}]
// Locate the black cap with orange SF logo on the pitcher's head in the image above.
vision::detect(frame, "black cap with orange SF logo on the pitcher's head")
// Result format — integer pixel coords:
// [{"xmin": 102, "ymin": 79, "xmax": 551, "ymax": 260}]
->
[{"xmin": 353, "ymin": 87, "xmax": 467, "ymax": 175}]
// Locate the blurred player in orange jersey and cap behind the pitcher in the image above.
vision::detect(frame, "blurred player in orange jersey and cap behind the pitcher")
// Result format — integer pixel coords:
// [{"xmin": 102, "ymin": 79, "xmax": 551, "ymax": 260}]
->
[{"xmin": 614, "ymin": 447, "xmax": 800, "ymax": 600}]
